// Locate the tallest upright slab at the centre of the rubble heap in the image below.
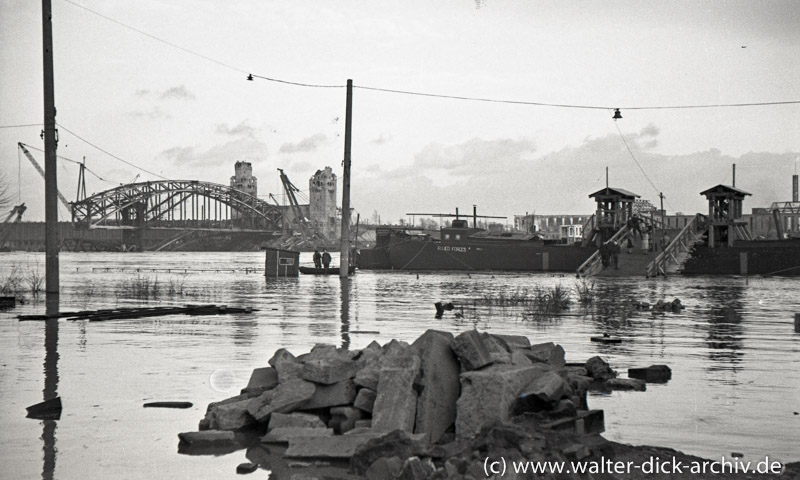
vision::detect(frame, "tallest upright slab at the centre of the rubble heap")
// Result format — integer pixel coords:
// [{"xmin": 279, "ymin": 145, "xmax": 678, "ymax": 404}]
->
[{"xmin": 412, "ymin": 330, "xmax": 461, "ymax": 443}]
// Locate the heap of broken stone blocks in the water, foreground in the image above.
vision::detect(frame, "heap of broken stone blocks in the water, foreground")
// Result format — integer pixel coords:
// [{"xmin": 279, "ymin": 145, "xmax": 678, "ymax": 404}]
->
[{"xmin": 179, "ymin": 330, "xmax": 668, "ymax": 479}]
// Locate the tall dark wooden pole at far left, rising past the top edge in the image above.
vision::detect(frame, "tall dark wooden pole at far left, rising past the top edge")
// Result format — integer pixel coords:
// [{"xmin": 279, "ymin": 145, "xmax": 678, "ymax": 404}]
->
[{"xmin": 42, "ymin": 0, "xmax": 59, "ymax": 316}]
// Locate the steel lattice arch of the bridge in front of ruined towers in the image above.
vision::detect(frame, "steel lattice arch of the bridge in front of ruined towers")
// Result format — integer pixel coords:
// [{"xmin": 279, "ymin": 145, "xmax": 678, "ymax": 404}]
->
[{"xmin": 72, "ymin": 180, "xmax": 283, "ymax": 231}]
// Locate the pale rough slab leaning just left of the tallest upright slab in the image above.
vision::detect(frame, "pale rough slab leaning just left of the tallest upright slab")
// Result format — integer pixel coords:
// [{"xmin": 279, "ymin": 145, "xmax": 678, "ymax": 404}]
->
[{"xmin": 372, "ymin": 352, "xmax": 420, "ymax": 432}]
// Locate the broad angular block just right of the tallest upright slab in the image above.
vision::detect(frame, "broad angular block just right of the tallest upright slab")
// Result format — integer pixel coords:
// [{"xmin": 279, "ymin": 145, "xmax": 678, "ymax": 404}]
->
[{"xmin": 456, "ymin": 364, "xmax": 551, "ymax": 439}]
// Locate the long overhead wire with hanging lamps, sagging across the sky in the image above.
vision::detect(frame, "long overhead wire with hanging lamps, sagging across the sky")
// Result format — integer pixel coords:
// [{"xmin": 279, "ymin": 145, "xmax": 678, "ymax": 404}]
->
[{"xmin": 57, "ymin": 0, "xmax": 800, "ymax": 110}]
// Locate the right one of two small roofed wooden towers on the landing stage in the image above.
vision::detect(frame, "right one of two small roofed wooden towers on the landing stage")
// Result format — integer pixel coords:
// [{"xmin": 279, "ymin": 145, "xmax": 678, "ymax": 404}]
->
[{"xmin": 700, "ymin": 184, "xmax": 752, "ymax": 248}]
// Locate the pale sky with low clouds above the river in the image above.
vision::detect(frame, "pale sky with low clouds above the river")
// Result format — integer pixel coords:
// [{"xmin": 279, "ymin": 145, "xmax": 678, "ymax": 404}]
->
[{"xmin": 0, "ymin": 0, "xmax": 800, "ymax": 223}]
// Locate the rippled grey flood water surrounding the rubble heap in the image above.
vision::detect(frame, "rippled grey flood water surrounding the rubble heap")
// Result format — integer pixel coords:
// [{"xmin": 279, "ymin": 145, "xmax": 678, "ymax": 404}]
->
[{"xmin": 0, "ymin": 252, "xmax": 800, "ymax": 479}]
